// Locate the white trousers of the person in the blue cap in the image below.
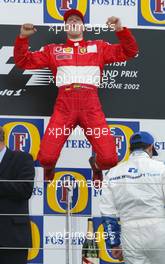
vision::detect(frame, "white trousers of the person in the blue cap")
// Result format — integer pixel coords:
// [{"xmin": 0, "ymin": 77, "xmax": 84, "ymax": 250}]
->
[{"xmin": 121, "ymin": 218, "xmax": 165, "ymax": 264}]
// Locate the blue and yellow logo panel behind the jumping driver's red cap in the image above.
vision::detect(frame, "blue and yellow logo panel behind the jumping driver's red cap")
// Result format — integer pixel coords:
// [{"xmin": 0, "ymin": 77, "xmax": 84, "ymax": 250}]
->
[{"xmin": 44, "ymin": 0, "xmax": 89, "ymax": 23}]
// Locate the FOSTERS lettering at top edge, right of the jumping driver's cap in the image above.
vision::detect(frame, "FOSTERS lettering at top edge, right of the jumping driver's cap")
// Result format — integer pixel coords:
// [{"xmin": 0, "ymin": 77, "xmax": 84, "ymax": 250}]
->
[{"xmin": 91, "ymin": 0, "xmax": 136, "ymax": 6}]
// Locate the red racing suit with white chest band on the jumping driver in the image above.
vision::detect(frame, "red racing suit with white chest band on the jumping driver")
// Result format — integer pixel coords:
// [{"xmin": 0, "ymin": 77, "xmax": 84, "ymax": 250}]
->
[{"xmin": 14, "ymin": 28, "xmax": 138, "ymax": 169}]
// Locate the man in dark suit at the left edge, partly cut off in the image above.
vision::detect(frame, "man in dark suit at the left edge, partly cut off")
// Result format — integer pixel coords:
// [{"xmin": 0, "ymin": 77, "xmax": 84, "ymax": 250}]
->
[{"xmin": 0, "ymin": 127, "xmax": 35, "ymax": 264}]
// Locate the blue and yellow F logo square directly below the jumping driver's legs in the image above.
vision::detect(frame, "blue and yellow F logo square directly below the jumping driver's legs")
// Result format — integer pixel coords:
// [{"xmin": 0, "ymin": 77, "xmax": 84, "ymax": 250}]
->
[{"xmin": 44, "ymin": 169, "xmax": 91, "ymax": 215}]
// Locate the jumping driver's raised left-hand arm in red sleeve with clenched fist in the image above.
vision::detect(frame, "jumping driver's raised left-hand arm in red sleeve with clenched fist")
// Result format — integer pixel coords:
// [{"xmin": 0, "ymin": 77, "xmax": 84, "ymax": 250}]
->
[{"xmin": 14, "ymin": 24, "xmax": 49, "ymax": 69}]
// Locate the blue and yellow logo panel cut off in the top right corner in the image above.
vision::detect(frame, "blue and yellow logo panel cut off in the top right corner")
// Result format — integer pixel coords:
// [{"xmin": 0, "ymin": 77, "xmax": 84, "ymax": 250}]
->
[{"xmin": 138, "ymin": 0, "xmax": 165, "ymax": 26}]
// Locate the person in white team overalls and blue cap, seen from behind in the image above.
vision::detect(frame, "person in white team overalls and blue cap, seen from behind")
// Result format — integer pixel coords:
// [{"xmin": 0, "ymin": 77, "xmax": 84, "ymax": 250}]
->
[{"xmin": 100, "ymin": 131, "xmax": 165, "ymax": 264}]
